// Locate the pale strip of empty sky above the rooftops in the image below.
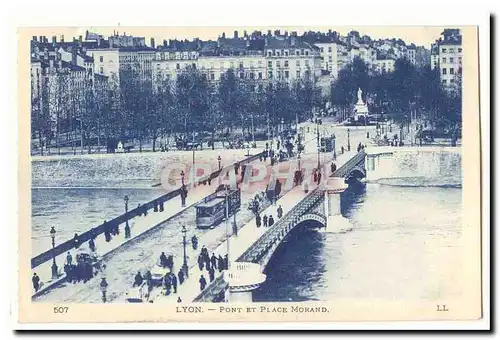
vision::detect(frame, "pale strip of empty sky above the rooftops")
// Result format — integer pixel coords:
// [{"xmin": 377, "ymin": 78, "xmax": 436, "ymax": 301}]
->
[{"xmin": 32, "ymin": 26, "xmax": 451, "ymax": 48}]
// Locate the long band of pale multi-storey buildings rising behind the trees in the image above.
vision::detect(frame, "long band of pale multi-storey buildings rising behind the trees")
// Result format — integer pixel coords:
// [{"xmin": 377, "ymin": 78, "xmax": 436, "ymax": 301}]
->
[{"xmin": 31, "ymin": 30, "xmax": 434, "ymax": 95}]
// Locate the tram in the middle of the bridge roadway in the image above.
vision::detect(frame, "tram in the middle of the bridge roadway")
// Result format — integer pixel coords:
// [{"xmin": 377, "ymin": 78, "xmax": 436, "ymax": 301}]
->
[{"xmin": 195, "ymin": 184, "xmax": 241, "ymax": 229}]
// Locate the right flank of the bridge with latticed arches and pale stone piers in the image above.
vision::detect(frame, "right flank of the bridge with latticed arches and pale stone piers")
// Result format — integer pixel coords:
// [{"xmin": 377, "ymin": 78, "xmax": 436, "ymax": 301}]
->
[{"xmin": 188, "ymin": 150, "xmax": 366, "ymax": 303}]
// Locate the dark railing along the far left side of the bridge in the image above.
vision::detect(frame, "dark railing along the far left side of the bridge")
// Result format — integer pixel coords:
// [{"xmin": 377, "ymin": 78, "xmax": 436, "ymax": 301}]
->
[{"xmin": 31, "ymin": 152, "xmax": 263, "ymax": 269}]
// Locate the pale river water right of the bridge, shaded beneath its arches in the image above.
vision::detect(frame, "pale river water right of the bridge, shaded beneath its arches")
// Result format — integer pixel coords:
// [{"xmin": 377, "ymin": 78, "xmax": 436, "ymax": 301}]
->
[{"xmin": 253, "ymin": 178, "xmax": 462, "ymax": 301}]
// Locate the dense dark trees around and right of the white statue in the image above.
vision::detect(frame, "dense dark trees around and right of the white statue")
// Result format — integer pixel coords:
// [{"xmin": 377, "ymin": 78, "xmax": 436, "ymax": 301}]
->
[{"xmin": 331, "ymin": 58, "xmax": 462, "ymax": 135}]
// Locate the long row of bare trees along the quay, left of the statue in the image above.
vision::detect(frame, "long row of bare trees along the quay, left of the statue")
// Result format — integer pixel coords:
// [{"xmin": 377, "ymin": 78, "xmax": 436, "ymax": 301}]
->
[{"xmin": 32, "ymin": 65, "xmax": 320, "ymax": 152}]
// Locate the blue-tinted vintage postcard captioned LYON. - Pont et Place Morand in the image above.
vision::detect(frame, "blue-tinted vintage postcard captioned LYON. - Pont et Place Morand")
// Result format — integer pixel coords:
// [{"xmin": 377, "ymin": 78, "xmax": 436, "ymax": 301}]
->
[{"xmin": 18, "ymin": 26, "xmax": 483, "ymax": 324}]
